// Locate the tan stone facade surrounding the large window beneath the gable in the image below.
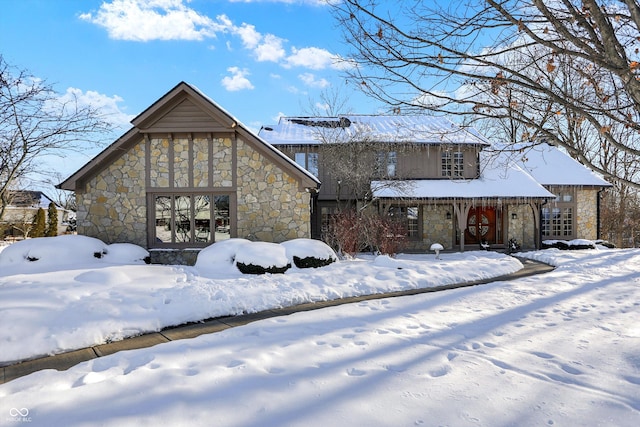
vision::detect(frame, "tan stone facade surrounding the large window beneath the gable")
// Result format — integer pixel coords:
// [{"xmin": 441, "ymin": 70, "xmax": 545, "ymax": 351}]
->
[{"xmin": 77, "ymin": 132, "xmax": 310, "ymax": 264}]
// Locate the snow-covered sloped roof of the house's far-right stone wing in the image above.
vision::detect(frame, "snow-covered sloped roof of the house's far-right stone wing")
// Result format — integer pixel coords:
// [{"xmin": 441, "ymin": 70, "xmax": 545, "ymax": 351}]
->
[{"xmin": 504, "ymin": 144, "xmax": 611, "ymax": 187}]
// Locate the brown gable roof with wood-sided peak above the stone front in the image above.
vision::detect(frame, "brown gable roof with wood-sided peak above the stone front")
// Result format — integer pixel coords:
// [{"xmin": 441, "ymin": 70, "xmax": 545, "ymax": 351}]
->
[{"xmin": 57, "ymin": 82, "xmax": 320, "ymax": 191}]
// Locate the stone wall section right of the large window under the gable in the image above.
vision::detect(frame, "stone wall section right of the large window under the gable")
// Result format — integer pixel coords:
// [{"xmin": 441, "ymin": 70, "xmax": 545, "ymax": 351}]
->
[{"xmin": 237, "ymin": 140, "xmax": 311, "ymax": 243}]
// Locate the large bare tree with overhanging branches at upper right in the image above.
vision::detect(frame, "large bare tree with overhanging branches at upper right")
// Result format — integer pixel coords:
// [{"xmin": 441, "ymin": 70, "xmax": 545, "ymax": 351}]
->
[{"xmin": 334, "ymin": 0, "xmax": 640, "ymax": 188}]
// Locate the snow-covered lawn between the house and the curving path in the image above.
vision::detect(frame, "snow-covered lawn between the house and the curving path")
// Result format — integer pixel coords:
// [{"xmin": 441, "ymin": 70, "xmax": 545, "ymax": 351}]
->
[{"xmin": 0, "ymin": 236, "xmax": 522, "ymax": 366}]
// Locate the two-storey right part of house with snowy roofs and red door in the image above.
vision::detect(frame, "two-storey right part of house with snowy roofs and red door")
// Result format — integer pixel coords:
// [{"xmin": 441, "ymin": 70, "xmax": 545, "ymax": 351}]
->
[{"xmin": 258, "ymin": 115, "xmax": 608, "ymax": 251}]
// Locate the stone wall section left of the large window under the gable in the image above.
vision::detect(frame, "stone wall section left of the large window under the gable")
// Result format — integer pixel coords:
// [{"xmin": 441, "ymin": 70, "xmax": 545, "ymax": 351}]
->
[{"xmin": 76, "ymin": 141, "xmax": 147, "ymax": 247}]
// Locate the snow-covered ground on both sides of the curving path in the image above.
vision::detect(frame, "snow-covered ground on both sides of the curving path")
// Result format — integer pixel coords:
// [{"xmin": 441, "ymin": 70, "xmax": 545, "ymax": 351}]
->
[{"xmin": 0, "ymin": 239, "xmax": 640, "ymax": 426}]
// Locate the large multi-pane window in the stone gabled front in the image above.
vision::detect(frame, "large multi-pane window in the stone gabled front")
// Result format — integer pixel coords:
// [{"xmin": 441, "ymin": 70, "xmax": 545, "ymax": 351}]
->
[{"xmin": 153, "ymin": 194, "xmax": 231, "ymax": 246}]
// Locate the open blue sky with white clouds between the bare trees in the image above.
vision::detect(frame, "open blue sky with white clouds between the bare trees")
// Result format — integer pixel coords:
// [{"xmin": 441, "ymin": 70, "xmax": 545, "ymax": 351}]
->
[{"xmin": 0, "ymin": 0, "xmax": 384, "ymax": 180}]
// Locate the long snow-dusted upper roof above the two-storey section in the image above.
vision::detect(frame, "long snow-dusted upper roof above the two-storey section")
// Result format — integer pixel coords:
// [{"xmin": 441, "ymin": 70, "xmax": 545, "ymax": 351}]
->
[{"xmin": 258, "ymin": 115, "xmax": 490, "ymax": 146}]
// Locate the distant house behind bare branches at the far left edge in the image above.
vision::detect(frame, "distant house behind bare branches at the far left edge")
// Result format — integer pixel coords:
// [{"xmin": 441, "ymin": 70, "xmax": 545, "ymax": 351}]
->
[{"xmin": 0, "ymin": 190, "xmax": 73, "ymax": 239}]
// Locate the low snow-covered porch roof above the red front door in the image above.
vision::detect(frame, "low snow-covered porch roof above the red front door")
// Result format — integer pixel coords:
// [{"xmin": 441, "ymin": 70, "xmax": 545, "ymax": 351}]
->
[{"xmin": 371, "ymin": 152, "xmax": 555, "ymax": 199}]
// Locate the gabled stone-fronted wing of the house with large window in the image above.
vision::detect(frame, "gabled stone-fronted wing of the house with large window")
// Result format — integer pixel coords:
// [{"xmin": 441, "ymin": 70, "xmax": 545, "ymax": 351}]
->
[{"xmin": 59, "ymin": 82, "xmax": 320, "ymax": 264}]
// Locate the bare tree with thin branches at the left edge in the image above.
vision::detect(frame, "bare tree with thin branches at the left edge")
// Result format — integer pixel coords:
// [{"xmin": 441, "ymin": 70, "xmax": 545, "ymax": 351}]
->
[{"xmin": 0, "ymin": 56, "xmax": 112, "ymax": 218}]
